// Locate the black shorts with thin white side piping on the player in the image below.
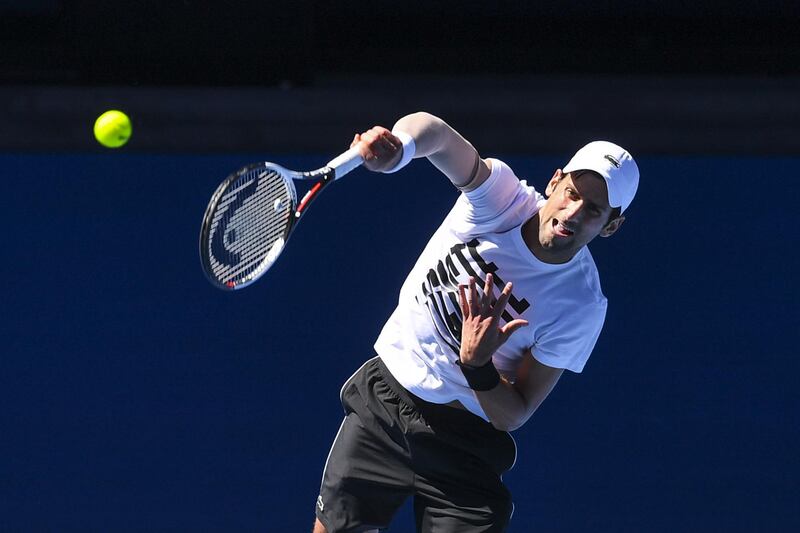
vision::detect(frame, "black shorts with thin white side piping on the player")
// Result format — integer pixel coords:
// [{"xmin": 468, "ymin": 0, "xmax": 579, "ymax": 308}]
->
[{"xmin": 317, "ymin": 357, "xmax": 516, "ymax": 533}]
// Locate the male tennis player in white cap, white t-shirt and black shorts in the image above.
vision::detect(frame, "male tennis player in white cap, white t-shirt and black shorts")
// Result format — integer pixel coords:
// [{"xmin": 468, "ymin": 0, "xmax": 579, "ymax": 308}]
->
[{"xmin": 314, "ymin": 113, "xmax": 639, "ymax": 533}]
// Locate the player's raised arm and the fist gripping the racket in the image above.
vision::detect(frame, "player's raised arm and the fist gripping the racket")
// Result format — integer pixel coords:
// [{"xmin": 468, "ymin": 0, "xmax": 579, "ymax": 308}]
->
[{"xmin": 353, "ymin": 111, "xmax": 491, "ymax": 191}]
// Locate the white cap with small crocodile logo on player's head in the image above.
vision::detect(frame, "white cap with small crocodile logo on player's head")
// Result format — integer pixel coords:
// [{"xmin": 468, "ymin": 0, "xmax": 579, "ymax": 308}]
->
[{"xmin": 562, "ymin": 141, "xmax": 639, "ymax": 212}]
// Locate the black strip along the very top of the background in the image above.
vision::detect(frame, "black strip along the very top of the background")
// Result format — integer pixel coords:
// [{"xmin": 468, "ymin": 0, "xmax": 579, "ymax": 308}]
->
[{"xmin": 0, "ymin": 0, "xmax": 800, "ymax": 85}]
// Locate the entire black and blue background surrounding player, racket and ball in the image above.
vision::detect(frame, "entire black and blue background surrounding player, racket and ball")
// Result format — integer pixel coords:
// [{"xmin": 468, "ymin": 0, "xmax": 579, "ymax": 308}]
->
[{"xmin": 0, "ymin": 0, "xmax": 800, "ymax": 533}]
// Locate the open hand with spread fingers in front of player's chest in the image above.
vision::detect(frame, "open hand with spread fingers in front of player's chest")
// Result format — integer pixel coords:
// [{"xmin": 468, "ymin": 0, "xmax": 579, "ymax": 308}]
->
[{"xmin": 458, "ymin": 274, "xmax": 528, "ymax": 367}]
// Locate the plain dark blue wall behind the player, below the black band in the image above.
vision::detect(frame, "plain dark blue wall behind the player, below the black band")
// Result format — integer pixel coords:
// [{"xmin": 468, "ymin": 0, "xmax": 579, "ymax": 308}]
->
[{"xmin": 0, "ymin": 152, "xmax": 800, "ymax": 532}]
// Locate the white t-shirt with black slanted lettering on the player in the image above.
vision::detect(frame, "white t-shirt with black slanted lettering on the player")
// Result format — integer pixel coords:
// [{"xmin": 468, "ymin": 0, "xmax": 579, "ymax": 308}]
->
[{"xmin": 375, "ymin": 159, "xmax": 607, "ymax": 420}]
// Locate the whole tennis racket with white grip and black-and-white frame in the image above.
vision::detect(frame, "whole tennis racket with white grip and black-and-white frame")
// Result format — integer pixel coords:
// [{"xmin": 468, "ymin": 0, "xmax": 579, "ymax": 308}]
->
[{"xmin": 200, "ymin": 147, "xmax": 364, "ymax": 291}]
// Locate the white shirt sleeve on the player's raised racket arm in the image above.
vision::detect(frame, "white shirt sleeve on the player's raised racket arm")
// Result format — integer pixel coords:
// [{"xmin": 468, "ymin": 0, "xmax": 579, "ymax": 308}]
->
[{"xmin": 449, "ymin": 159, "xmax": 542, "ymax": 238}]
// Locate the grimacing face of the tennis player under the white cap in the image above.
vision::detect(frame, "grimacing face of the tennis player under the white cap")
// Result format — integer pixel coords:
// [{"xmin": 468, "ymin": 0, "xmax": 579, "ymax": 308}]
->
[{"xmin": 534, "ymin": 170, "xmax": 625, "ymax": 263}]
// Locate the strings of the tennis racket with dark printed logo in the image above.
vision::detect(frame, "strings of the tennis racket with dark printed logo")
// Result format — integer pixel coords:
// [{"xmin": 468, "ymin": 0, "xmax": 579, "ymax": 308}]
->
[{"xmin": 208, "ymin": 168, "xmax": 294, "ymax": 285}]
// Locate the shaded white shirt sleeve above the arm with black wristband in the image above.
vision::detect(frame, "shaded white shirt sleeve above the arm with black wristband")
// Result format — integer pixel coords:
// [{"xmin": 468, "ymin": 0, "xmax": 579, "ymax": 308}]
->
[{"xmin": 531, "ymin": 299, "xmax": 607, "ymax": 373}]
